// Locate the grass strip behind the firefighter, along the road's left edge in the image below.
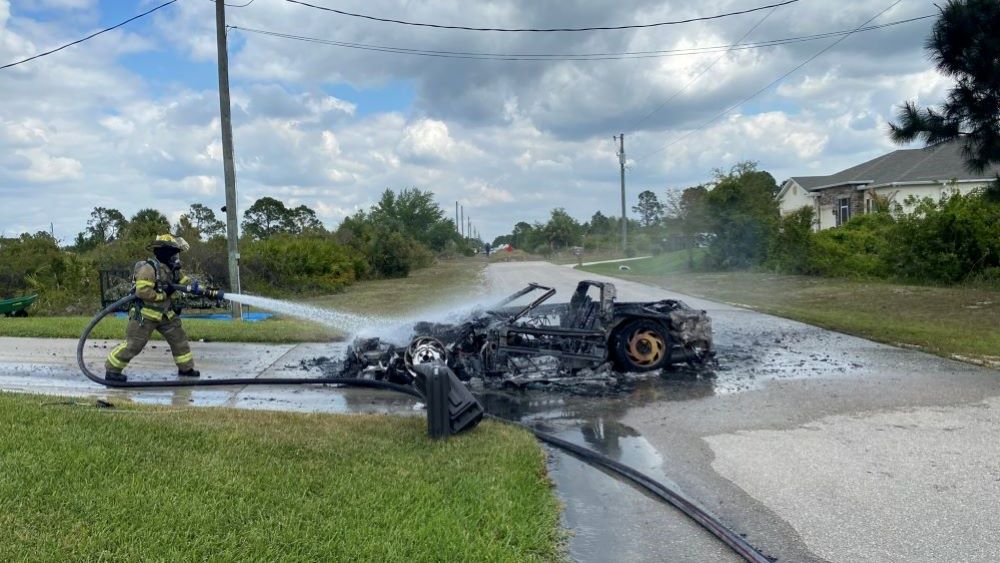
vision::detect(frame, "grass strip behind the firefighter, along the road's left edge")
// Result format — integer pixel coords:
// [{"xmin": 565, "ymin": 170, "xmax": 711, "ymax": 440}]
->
[{"xmin": 0, "ymin": 258, "xmax": 485, "ymax": 343}]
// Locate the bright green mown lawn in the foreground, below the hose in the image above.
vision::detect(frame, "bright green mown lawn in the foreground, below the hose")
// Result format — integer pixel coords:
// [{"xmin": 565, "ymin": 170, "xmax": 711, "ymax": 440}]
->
[{"xmin": 0, "ymin": 394, "xmax": 562, "ymax": 561}]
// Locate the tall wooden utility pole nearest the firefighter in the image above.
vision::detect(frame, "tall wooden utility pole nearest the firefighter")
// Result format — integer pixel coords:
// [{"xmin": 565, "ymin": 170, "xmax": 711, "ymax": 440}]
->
[{"xmin": 215, "ymin": 0, "xmax": 243, "ymax": 321}]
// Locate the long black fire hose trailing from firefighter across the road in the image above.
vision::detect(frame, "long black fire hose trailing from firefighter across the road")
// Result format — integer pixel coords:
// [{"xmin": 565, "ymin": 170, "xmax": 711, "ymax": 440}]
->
[{"xmin": 76, "ymin": 295, "xmax": 771, "ymax": 563}]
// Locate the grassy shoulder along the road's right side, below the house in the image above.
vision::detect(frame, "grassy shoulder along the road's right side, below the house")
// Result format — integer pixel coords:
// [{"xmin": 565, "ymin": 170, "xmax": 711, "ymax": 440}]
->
[{"xmin": 584, "ymin": 253, "xmax": 1000, "ymax": 365}]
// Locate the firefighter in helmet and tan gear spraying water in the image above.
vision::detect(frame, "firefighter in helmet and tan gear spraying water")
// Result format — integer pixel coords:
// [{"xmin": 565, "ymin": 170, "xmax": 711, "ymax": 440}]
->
[{"xmin": 104, "ymin": 234, "xmax": 203, "ymax": 381}]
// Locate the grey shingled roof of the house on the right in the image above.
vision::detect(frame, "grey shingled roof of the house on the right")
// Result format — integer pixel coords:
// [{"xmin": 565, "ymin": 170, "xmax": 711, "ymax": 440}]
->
[{"xmin": 790, "ymin": 141, "xmax": 1000, "ymax": 191}]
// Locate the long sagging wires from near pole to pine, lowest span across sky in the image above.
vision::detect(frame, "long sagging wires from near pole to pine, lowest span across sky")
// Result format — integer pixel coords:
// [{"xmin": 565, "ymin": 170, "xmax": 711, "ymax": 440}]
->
[{"xmin": 228, "ymin": 14, "xmax": 937, "ymax": 61}]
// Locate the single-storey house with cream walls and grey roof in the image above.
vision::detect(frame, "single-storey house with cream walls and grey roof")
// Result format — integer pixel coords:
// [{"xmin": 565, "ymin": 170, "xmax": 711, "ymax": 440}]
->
[{"xmin": 777, "ymin": 141, "xmax": 1000, "ymax": 230}]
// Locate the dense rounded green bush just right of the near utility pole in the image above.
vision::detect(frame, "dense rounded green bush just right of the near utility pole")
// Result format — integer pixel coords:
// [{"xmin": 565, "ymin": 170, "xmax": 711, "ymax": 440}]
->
[{"xmin": 240, "ymin": 235, "xmax": 357, "ymax": 295}]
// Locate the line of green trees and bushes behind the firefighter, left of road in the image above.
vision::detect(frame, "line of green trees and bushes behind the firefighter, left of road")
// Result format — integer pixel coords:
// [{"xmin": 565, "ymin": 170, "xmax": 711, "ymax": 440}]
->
[{"xmin": 0, "ymin": 188, "xmax": 481, "ymax": 314}]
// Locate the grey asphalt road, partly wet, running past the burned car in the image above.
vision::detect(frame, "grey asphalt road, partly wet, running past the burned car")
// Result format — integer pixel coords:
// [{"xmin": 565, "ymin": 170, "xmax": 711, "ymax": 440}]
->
[{"xmin": 487, "ymin": 263, "xmax": 1000, "ymax": 562}]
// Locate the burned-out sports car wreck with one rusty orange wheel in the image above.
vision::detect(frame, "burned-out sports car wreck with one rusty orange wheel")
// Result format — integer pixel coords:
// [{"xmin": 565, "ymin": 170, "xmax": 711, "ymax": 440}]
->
[{"xmin": 342, "ymin": 281, "xmax": 712, "ymax": 386}]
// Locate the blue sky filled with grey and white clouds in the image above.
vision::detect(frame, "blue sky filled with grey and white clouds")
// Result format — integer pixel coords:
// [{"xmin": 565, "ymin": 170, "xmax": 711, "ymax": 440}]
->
[{"xmin": 0, "ymin": 0, "xmax": 951, "ymax": 243}]
